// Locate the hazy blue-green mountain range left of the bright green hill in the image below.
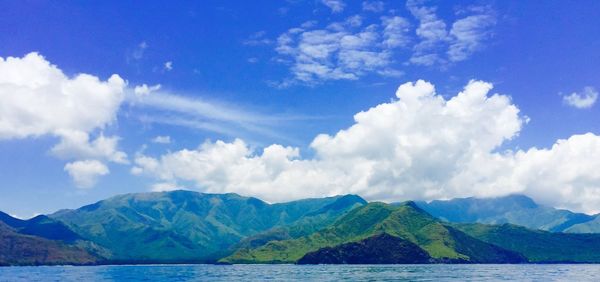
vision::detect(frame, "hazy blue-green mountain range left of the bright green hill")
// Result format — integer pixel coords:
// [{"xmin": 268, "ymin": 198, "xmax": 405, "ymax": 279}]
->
[{"xmin": 50, "ymin": 191, "xmax": 366, "ymax": 263}]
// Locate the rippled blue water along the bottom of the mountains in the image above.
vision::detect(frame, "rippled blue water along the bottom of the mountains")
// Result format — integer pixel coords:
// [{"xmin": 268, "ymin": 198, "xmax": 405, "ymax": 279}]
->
[{"xmin": 0, "ymin": 264, "xmax": 600, "ymax": 282}]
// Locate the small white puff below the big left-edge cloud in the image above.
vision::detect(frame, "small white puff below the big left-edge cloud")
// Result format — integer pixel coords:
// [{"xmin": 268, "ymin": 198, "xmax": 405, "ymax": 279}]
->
[{"xmin": 64, "ymin": 160, "xmax": 109, "ymax": 188}]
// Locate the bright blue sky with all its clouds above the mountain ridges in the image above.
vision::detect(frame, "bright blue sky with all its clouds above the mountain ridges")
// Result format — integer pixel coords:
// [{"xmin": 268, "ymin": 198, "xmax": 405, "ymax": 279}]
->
[{"xmin": 0, "ymin": 0, "xmax": 600, "ymax": 218}]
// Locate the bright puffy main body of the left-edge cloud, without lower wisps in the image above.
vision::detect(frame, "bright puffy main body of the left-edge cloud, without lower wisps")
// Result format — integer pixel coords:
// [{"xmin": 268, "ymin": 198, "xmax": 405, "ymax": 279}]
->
[{"xmin": 0, "ymin": 53, "xmax": 125, "ymax": 139}]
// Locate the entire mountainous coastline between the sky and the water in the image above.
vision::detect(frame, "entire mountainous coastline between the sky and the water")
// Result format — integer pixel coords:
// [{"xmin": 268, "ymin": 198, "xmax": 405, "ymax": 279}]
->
[{"xmin": 0, "ymin": 190, "xmax": 600, "ymax": 265}]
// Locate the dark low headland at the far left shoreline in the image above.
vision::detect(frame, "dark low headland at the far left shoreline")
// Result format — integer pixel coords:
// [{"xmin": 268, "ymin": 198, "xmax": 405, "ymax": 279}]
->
[{"xmin": 0, "ymin": 222, "xmax": 103, "ymax": 265}]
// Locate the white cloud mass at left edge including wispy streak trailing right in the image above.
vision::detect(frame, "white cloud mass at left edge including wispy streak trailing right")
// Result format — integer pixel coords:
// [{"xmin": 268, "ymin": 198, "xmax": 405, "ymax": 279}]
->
[{"xmin": 0, "ymin": 52, "xmax": 307, "ymax": 188}]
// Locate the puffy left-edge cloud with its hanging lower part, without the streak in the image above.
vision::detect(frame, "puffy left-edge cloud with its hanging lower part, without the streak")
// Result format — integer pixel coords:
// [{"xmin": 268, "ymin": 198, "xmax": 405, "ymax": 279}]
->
[{"xmin": 0, "ymin": 53, "xmax": 127, "ymax": 187}]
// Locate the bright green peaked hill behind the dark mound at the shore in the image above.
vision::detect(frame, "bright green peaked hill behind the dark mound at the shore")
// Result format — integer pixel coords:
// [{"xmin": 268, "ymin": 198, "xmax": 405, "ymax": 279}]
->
[{"xmin": 220, "ymin": 202, "xmax": 525, "ymax": 263}]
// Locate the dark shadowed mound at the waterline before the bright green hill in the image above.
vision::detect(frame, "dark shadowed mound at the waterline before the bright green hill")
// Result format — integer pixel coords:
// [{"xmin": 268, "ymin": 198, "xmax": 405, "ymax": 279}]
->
[{"xmin": 298, "ymin": 233, "xmax": 433, "ymax": 264}]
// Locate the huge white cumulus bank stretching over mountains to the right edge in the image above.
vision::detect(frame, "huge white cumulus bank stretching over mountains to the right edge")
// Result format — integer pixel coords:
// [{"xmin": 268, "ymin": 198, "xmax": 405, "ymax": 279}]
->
[{"xmin": 132, "ymin": 80, "xmax": 600, "ymax": 212}]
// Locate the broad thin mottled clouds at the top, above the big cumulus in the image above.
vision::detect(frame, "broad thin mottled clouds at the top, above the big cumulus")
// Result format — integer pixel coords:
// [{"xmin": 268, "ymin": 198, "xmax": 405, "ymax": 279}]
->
[{"xmin": 274, "ymin": 0, "xmax": 496, "ymax": 85}]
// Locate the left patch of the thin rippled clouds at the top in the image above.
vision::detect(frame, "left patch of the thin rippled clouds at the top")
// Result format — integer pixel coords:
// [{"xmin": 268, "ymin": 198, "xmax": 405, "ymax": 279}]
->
[{"xmin": 276, "ymin": 16, "xmax": 408, "ymax": 87}]
